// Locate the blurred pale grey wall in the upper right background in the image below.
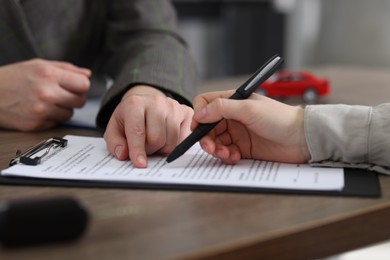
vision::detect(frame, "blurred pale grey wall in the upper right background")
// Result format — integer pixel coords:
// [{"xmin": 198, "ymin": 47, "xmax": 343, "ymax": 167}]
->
[{"xmin": 280, "ymin": 0, "xmax": 390, "ymax": 69}]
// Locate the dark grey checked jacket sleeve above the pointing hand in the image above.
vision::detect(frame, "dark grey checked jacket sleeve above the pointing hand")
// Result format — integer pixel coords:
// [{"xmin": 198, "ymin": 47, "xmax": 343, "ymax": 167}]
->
[{"xmin": 96, "ymin": 0, "xmax": 197, "ymax": 129}]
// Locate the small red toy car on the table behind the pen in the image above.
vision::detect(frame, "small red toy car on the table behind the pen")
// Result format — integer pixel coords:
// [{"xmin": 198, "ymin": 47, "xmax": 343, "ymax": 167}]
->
[{"xmin": 256, "ymin": 70, "xmax": 330, "ymax": 103}]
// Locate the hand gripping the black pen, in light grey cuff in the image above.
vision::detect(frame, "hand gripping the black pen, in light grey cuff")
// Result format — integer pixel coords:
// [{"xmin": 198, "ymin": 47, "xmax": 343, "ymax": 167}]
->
[{"xmin": 191, "ymin": 91, "xmax": 310, "ymax": 164}]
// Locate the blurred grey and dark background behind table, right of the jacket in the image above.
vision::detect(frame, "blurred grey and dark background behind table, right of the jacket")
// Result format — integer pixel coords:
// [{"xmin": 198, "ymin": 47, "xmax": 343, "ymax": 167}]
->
[{"xmin": 173, "ymin": 0, "xmax": 390, "ymax": 79}]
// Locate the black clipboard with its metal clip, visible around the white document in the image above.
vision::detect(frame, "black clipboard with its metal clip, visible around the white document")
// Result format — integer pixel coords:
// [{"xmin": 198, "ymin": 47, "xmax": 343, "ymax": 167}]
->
[{"xmin": 0, "ymin": 137, "xmax": 381, "ymax": 197}]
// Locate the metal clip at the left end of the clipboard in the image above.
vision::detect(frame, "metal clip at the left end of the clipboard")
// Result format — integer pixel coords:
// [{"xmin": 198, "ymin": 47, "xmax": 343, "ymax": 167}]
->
[{"xmin": 9, "ymin": 137, "xmax": 68, "ymax": 166}]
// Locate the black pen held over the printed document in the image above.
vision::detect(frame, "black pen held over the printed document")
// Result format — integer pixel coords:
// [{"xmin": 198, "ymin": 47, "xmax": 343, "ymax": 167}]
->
[{"xmin": 167, "ymin": 55, "xmax": 283, "ymax": 163}]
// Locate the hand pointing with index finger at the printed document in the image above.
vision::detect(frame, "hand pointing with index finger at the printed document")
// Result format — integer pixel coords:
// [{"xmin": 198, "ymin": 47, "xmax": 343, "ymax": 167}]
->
[{"xmin": 104, "ymin": 86, "xmax": 193, "ymax": 168}]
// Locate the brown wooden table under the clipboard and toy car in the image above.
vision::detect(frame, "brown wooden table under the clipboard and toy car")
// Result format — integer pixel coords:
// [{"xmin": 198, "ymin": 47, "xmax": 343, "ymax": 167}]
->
[{"xmin": 0, "ymin": 68, "xmax": 390, "ymax": 260}]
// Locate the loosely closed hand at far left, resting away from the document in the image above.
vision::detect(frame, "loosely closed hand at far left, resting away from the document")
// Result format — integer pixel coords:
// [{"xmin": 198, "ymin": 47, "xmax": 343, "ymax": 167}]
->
[{"xmin": 0, "ymin": 59, "xmax": 91, "ymax": 131}]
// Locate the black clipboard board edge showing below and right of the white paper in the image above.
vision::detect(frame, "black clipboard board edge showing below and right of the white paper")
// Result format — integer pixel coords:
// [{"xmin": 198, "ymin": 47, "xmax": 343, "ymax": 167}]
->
[{"xmin": 0, "ymin": 169, "xmax": 381, "ymax": 198}]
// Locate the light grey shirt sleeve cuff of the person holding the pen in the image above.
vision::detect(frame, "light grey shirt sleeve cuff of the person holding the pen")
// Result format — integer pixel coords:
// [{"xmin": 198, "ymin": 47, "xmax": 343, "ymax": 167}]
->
[{"xmin": 304, "ymin": 103, "xmax": 390, "ymax": 174}]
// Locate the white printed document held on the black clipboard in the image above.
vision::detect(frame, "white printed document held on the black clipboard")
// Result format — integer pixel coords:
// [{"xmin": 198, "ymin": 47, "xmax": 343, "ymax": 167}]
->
[{"xmin": 1, "ymin": 135, "xmax": 344, "ymax": 190}]
